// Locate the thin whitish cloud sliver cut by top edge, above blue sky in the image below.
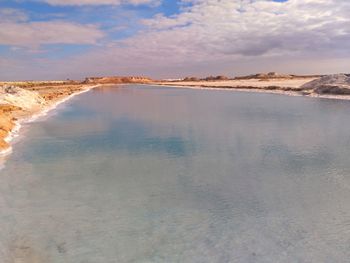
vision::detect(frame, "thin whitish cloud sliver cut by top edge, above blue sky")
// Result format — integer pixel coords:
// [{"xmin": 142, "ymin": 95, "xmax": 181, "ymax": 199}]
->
[{"xmin": 41, "ymin": 0, "xmax": 160, "ymax": 6}]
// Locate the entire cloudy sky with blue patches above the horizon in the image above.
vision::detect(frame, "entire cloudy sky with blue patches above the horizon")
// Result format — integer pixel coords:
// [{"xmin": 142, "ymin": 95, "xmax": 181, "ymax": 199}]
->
[{"xmin": 0, "ymin": 0, "xmax": 350, "ymax": 80}]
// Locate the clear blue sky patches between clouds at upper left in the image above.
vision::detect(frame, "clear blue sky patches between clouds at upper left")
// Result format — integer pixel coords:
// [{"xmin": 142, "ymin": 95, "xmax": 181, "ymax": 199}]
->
[{"xmin": 0, "ymin": 0, "xmax": 180, "ymax": 47}]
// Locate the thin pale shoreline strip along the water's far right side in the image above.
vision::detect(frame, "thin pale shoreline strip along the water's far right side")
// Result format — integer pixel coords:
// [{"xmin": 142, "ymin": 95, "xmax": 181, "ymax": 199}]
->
[{"xmin": 152, "ymin": 83, "xmax": 350, "ymax": 101}]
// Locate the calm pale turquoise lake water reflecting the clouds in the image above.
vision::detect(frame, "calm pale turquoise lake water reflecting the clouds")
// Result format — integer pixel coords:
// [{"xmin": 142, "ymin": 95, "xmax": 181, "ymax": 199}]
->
[{"xmin": 0, "ymin": 86, "xmax": 350, "ymax": 263}]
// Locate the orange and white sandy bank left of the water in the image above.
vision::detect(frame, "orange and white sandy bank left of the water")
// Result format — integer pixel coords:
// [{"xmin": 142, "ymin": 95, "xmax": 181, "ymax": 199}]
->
[{"xmin": 0, "ymin": 82, "xmax": 97, "ymax": 159}]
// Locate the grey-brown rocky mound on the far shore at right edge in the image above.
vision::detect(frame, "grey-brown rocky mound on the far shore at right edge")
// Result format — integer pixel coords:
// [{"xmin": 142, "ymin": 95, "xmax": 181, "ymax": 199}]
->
[{"xmin": 301, "ymin": 74, "xmax": 350, "ymax": 95}]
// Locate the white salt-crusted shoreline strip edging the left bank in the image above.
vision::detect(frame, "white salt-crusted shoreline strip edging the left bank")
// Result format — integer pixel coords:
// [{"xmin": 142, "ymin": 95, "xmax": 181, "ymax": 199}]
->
[{"xmin": 0, "ymin": 84, "xmax": 101, "ymax": 162}]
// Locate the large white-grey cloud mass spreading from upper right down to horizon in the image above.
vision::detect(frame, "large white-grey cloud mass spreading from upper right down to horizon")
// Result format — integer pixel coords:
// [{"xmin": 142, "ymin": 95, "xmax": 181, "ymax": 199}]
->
[{"xmin": 0, "ymin": 0, "xmax": 350, "ymax": 78}]
